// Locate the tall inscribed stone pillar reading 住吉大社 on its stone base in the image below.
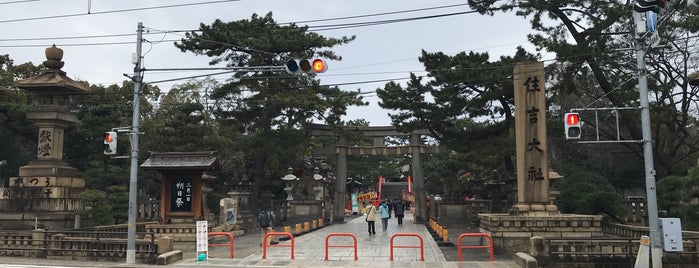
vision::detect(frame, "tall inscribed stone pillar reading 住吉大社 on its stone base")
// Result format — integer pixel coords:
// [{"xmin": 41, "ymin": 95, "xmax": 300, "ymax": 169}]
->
[{"xmin": 478, "ymin": 62, "xmax": 603, "ymax": 253}]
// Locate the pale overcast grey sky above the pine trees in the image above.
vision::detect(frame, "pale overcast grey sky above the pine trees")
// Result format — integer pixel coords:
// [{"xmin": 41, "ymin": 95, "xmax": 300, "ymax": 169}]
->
[{"xmin": 0, "ymin": 0, "xmax": 531, "ymax": 126}]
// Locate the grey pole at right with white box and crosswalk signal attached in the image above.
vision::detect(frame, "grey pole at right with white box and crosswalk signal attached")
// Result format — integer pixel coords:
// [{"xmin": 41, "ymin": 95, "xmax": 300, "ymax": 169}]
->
[{"xmin": 633, "ymin": 12, "xmax": 663, "ymax": 268}]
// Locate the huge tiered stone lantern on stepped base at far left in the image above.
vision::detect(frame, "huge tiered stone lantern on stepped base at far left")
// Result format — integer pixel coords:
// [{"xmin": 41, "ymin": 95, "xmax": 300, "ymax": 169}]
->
[{"xmin": 0, "ymin": 46, "xmax": 89, "ymax": 228}]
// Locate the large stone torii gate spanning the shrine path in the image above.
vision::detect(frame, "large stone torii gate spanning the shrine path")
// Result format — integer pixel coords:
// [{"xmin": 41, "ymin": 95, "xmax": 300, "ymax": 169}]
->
[{"xmin": 305, "ymin": 124, "xmax": 448, "ymax": 223}]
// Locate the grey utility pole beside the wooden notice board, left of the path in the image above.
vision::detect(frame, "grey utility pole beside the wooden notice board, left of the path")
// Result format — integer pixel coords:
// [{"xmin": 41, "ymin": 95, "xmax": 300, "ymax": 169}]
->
[{"xmin": 126, "ymin": 22, "xmax": 143, "ymax": 264}]
